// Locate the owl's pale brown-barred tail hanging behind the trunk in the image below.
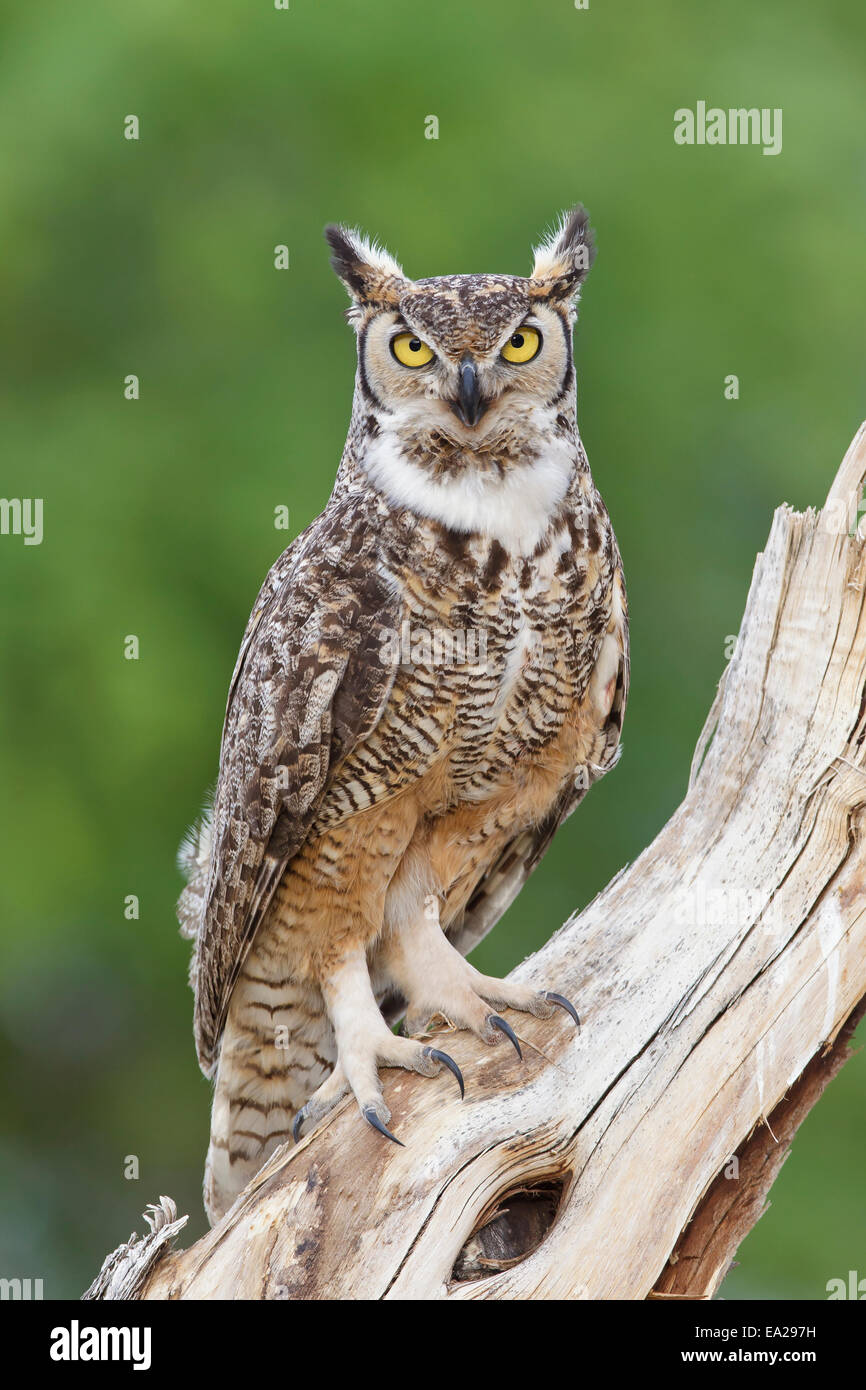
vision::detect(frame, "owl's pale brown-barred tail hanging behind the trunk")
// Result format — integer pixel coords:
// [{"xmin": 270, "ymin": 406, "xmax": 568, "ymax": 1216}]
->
[{"xmin": 204, "ymin": 973, "xmax": 336, "ymax": 1226}]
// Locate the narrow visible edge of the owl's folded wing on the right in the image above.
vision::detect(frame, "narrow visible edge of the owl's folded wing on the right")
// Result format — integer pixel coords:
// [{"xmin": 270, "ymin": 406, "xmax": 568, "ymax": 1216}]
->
[{"xmin": 448, "ymin": 549, "xmax": 631, "ymax": 955}]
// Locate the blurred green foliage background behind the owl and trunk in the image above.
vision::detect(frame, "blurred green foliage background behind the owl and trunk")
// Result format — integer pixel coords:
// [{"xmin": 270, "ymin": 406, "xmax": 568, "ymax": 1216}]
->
[{"xmin": 0, "ymin": 0, "xmax": 866, "ymax": 1298}]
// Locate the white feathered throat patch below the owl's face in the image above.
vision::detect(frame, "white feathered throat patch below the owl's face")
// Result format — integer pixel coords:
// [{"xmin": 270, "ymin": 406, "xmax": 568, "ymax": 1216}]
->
[{"xmin": 360, "ymin": 414, "xmax": 575, "ymax": 555}]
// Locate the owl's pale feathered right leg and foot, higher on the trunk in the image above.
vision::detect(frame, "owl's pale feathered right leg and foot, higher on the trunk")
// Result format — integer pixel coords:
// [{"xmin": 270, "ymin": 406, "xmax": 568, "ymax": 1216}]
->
[{"xmin": 379, "ymin": 898, "xmax": 580, "ymax": 1055}]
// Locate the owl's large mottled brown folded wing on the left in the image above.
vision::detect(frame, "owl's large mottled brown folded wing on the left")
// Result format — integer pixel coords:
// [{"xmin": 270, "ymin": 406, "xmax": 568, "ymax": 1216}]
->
[{"xmin": 193, "ymin": 518, "xmax": 399, "ymax": 1073}]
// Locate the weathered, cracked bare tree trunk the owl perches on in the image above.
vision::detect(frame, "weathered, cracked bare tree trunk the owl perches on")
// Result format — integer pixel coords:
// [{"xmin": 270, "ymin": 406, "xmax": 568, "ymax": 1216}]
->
[{"xmin": 89, "ymin": 425, "xmax": 866, "ymax": 1300}]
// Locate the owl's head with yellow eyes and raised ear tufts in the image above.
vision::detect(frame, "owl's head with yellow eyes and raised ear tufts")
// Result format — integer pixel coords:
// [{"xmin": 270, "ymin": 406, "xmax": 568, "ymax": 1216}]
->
[{"xmin": 325, "ymin": 207, "xmax": 594, "ymax": 439}]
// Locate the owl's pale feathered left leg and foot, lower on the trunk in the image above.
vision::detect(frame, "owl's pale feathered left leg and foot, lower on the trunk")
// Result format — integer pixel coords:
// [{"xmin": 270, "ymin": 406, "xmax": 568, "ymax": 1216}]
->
[{"xmin": 293, "ymin": 949, "xmax": 463, "ymax": 1144}]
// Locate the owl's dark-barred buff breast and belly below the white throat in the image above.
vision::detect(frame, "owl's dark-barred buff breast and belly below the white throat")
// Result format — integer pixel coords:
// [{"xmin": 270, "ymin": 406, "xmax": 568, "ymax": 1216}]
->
[{"xmin": 315, "ymin": 500, "xmax": 613, "ymax": 821}]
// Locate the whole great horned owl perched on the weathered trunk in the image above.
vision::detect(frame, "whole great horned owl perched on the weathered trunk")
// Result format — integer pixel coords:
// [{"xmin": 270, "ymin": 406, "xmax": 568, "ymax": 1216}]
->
[{"xmin": 179, "ymin": 207, "xmax": 628, "ymax": 1222}]
